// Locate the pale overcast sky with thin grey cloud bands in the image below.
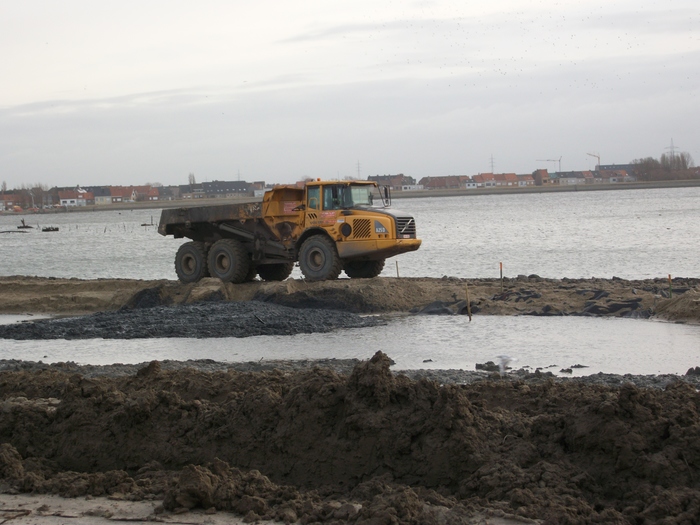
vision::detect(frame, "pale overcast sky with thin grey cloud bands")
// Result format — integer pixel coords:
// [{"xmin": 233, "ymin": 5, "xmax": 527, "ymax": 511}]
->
[{"xmin": 0, "ymin": 0, "xmax": 700, "ymax": 189}]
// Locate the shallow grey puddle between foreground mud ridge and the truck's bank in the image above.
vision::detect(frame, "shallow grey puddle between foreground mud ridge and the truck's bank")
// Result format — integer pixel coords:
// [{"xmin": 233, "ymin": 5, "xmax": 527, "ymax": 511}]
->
[{"xmin": 0, "ymin": 316, "xmax": 700, "ymax": 377}]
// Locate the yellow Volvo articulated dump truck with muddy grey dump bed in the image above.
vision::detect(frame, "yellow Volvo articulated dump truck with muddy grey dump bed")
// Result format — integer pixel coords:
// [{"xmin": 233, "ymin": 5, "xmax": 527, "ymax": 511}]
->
[{"xmin": 158, "ymin": 180, "xmax": 421, "ymax": 283}]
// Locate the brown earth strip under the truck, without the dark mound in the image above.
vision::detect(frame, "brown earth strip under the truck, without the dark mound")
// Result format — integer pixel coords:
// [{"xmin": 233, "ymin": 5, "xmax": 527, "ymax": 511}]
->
[{"xmin": 0, "ymin": 276, "xmax": 700, "ymax": 322}]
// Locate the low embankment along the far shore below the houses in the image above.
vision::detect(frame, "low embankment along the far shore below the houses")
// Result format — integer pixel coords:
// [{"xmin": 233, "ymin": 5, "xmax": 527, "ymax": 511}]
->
[{"xmin": 0, "ymin": 180, "xmax": 700, "ymax": 216}]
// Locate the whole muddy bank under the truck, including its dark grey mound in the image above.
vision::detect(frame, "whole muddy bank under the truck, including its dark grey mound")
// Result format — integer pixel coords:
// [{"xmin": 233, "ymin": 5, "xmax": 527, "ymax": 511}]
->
[{"xmin": 0, "ymin": 276, "xmax": 700, "ymax": 339}]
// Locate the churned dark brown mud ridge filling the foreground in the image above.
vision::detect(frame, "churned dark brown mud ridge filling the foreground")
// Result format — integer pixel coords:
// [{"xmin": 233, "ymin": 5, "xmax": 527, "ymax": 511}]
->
[{"xmin": 0, "ymin": 353, "xmax": 700, "ymax": 524}]
